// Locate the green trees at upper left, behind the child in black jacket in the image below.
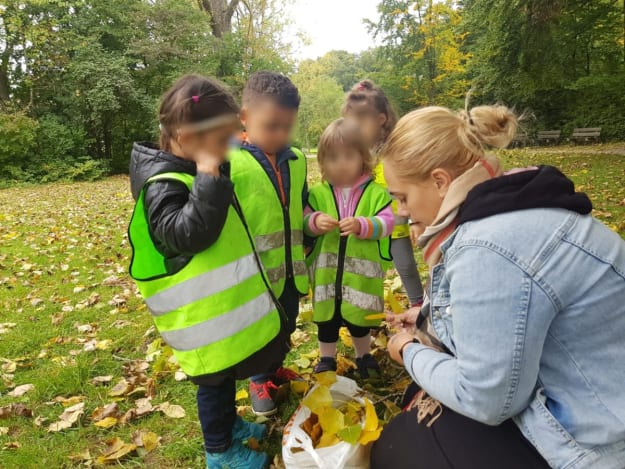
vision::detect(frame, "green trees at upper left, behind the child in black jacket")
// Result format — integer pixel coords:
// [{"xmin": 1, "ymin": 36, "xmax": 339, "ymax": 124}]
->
[{"xmin": 0, "ymin": 0, "xmax": 293, "ymax": 182}]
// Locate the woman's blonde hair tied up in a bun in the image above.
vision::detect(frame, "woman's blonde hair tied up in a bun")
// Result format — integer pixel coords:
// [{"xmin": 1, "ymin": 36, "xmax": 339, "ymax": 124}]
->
[{"xmin": 383, "ymin": 105, "xmax": 518, "ymax": 181}]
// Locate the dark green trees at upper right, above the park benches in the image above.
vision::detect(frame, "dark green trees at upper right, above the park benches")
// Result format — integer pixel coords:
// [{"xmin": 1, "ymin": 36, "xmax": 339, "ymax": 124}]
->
[{"xmin": 463, "ymin": 0, "xmax": 625, "ymax": 139}]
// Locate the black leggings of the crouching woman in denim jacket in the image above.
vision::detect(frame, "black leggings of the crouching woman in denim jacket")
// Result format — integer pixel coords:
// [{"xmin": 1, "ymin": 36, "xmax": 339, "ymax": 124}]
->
[{"xmin": 371, "ymin": 384, "xmax": 549, "ymax": 469}]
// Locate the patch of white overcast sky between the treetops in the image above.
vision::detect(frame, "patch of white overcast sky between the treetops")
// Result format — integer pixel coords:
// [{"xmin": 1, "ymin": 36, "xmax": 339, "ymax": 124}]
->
[{"xmin": 291, "ymin": 0, "xmax": 379, "ymax": 59}]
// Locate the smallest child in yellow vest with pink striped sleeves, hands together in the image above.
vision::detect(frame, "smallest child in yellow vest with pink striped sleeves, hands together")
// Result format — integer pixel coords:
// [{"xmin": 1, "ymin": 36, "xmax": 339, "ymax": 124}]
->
[{"xmin": 304, "ymin": 119, "xmax": 394, "ymax": 378}]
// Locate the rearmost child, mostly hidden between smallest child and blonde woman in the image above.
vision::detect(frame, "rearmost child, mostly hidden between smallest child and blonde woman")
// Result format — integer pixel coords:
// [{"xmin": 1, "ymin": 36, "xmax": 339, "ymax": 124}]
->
[{"xmin": 343, "ymin": 80, "xmax": 423, "ymax": 307}]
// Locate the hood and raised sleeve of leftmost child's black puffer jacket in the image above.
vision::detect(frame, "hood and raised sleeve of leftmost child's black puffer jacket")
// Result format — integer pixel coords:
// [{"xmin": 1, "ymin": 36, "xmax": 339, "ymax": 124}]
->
[{"xmin": 130, "ymin": 142, "xmax": 234, "ymax": 271}]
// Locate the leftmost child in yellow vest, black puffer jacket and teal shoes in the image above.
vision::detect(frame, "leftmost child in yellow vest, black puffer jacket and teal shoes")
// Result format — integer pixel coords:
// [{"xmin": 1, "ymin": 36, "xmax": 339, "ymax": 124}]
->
[{"xmin": 128, "ymin": 75, "xmax": 288, "ymax": 469}]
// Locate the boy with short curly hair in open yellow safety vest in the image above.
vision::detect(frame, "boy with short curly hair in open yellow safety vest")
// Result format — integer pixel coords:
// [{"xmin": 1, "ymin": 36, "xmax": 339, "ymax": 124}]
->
[{"xmin": 229, "ymin": 71, "xmax": 308, "ymax": 416}]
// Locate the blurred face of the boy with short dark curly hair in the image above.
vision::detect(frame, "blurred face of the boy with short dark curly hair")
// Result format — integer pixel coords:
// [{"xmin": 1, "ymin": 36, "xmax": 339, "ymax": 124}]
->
[{"xmin": 241, "ymin": 98, "xmax": 297, "ymax": 154}]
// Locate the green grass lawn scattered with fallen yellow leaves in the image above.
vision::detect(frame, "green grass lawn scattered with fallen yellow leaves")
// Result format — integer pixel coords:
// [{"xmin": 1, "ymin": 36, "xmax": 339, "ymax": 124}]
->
[{"xmin": 0, "ymin": 145, "xmax": 625, "ymax": 468}]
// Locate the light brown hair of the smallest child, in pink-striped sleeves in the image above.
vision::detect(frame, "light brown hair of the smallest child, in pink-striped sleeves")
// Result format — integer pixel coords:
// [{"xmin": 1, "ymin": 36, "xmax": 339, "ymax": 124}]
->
[{"xmin": 317, "ymin": 117, "xmax": 377, "ymax": 180}]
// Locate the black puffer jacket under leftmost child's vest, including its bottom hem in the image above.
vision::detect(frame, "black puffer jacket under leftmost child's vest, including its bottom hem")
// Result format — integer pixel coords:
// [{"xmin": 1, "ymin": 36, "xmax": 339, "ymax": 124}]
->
[{"xmin": 130, "ymin": 143, "xmax": 290, "ymax": 386}]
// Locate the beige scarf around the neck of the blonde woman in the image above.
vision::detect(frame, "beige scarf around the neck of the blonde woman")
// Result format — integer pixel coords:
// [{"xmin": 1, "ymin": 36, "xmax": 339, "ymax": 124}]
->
[{"xmin": 419, "ymin": 155, "xmax": 503, "ymax": 269}]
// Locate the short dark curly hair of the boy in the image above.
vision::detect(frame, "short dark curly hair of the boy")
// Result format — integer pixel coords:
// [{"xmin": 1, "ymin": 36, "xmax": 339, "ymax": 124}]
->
[{"xmin": 243, "ymin": 72, "xmax": 301, "ymax": 109}]
